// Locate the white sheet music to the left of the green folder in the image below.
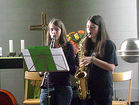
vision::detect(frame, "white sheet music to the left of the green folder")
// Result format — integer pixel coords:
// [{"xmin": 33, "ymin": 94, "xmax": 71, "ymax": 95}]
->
[{"xmin": 21, "ymin": 49, "xmax": 36, "ymax": 71}]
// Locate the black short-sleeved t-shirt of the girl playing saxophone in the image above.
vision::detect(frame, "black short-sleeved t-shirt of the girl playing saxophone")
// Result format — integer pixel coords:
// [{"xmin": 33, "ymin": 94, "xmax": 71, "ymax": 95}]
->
[{"xmin": 87, "ymin": 40, "xmax": 118, "ymax": 96}]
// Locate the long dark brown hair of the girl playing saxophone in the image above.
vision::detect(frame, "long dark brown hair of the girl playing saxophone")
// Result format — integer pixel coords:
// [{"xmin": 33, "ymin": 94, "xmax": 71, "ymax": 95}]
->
[{"xmin": 84, "ymin": 15, "xmax": 109, "ymax": 58}]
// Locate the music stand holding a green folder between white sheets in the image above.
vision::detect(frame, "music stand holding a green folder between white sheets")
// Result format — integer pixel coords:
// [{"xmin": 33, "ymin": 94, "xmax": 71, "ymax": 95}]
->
[{"xmin": 21, "ymin": 46, "xmax": 69, "ymax": 105}]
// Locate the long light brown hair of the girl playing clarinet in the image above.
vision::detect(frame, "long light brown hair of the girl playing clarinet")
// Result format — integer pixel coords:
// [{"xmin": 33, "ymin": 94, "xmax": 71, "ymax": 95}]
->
[{"xmin": 45, "ymin": 18, "xmax": 67, "ymax": 47}]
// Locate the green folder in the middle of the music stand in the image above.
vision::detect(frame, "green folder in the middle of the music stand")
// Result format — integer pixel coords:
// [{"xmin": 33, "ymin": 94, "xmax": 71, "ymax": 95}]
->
[{"xmin": 28, "ymin": 46, "xmax": 57, "ymax": 72}]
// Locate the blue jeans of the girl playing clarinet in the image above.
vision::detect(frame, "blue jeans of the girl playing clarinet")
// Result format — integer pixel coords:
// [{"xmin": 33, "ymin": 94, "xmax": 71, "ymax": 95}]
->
[{"xmin": 40, "ymin": 86, "xmax": 73, "ymax": 105}]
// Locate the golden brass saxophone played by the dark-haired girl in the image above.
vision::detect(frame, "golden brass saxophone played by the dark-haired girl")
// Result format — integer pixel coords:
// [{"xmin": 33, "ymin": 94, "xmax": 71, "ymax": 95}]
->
[{"xmin": 75, "ymin": 36, "xmax": 89, "ymax": 100}]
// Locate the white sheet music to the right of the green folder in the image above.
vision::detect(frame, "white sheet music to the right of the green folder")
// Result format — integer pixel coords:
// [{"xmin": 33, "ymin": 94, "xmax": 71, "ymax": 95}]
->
[{"xmin": 50, "ymin": 47, "xmax": 69, "ymax": 71}]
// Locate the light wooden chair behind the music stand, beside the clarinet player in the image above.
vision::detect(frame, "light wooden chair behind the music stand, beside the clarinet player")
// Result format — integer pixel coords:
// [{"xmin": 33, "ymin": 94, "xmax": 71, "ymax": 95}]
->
[{"xmin": 23, "ymin": 71, "xmax": 42, "ymax": 105}]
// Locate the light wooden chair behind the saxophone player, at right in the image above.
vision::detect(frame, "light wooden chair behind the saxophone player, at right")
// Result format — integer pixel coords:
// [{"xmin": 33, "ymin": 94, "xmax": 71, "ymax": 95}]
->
[{"xmin": 112, "ymin": 71, "xmax": 132, "ymax": 105}]
